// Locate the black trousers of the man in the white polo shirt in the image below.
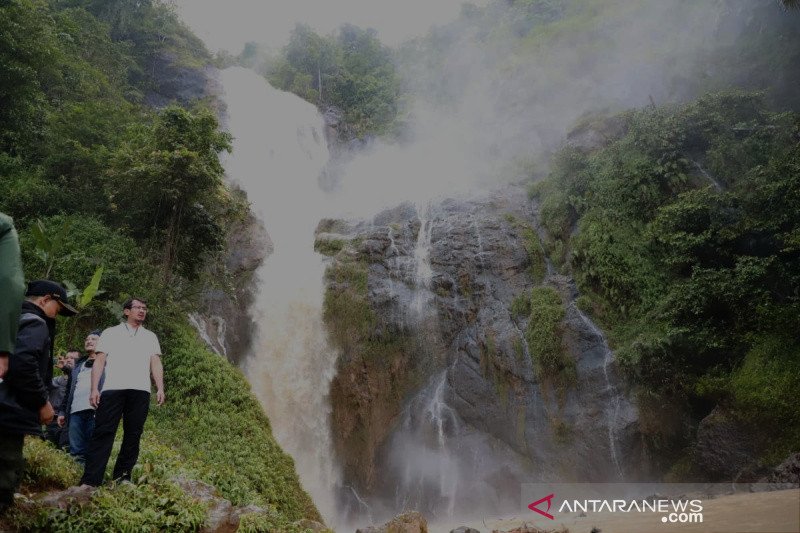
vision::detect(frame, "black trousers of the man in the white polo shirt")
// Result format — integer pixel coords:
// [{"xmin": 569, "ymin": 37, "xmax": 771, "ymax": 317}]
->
[{"xmin": 81, "ymin": 389, "xmax": 150, "ymax": 487}]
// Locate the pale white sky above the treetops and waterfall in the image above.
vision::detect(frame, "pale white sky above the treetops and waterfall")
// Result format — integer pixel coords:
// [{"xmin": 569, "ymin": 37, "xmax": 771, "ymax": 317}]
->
[{"xmin": 174, "ymin": 0, "xmax": 488, "ymax": 54}]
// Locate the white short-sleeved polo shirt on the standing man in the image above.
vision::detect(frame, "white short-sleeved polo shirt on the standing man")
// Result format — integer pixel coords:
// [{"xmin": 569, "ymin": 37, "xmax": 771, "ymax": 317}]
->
[{"xmin": 95, "ymin": 322, "xmax": 161, "ymax": 392}]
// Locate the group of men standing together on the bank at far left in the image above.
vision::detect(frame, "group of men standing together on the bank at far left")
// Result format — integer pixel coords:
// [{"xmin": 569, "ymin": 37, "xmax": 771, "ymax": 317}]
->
[{"xmin": 0, "ymin": 214, "xmax": 165, "ymax": 515}]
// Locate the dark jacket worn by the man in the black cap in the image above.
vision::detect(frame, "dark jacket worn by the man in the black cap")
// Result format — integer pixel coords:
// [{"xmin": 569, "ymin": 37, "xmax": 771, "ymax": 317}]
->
[{"xmin": 0, "ymin": 302, "xmax": 55, "ymax": 435}]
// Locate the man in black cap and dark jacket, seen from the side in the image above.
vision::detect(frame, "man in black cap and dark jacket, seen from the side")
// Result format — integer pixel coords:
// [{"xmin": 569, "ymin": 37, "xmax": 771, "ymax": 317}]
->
[{"xmin": 0, "ymin": 280, "xmax": 77, "ymax": 514}]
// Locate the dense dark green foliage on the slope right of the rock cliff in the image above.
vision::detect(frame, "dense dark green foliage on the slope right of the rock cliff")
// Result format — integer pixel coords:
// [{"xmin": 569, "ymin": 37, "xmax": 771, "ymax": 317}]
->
[{"xmin": 535, "ymin": 92, "xmax": 800, "ymax": 455}]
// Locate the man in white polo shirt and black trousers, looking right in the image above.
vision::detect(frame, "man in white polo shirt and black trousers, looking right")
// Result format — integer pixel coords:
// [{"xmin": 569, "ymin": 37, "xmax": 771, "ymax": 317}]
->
[{"xmin": 81, "ymin": 298, "xmax": 164, "ymax": 487}]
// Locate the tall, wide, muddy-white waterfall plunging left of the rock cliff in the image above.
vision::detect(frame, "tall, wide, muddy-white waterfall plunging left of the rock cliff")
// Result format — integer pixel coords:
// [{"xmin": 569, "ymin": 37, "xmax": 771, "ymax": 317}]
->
[{"xmin": 222, "ymin": 67, "xmax": 340, "ymax": 524}]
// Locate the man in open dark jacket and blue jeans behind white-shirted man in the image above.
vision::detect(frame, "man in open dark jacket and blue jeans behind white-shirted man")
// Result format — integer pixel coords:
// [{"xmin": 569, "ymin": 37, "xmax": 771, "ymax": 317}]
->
[{"xmin": 58, "ymin": 329, "xmax": 105, "ymax": 464}]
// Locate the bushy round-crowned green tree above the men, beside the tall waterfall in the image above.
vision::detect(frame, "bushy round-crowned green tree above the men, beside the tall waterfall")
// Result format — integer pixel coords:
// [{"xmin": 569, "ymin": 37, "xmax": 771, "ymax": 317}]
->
[{"xmin": 112, "ymin": 106, "xmax": 230, "ymax": 282}]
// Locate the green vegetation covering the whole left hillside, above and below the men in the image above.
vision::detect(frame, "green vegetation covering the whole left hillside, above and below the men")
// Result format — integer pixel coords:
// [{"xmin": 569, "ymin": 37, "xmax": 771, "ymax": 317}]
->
[{"xmin": 0, "ymin": 0, "xmax": 319, "ymax": 531}]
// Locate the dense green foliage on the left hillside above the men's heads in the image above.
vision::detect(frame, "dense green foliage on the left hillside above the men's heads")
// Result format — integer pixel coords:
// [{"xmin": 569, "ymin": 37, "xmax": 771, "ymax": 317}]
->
[{"xmin": 0, "ymin": 0, "xmax": 236, "ymax": 342}]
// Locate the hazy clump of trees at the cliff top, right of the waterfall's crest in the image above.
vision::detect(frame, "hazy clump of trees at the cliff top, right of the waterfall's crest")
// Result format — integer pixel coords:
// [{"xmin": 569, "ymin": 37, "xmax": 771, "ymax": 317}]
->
[{"xmin": 260, "ymin": 24, "xmax": 400, "ymax": 137}]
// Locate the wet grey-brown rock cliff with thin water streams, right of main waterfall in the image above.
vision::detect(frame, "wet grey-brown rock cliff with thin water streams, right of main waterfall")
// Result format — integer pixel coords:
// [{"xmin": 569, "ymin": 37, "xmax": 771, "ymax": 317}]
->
[{"xmin": 317, "ymin": 187, "xmax": 643, "ymax": 514}]
